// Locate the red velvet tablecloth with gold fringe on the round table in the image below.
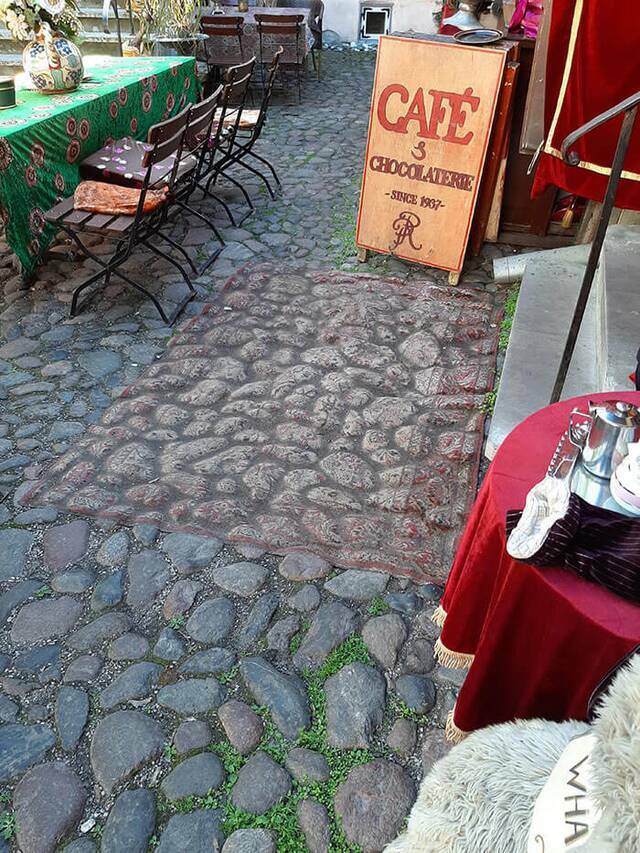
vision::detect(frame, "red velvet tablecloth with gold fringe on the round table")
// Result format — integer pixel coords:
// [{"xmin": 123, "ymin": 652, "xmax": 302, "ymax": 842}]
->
[{"xmin": 435, "ymin": 393, "xmax": 640, "ymax": 740}]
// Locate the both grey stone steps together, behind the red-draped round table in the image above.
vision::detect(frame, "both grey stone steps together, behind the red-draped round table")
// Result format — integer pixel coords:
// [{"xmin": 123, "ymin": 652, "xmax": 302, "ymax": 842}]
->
[{"xmin": 485, "ymin": 225, "xmax": 640, "ymax": 459}]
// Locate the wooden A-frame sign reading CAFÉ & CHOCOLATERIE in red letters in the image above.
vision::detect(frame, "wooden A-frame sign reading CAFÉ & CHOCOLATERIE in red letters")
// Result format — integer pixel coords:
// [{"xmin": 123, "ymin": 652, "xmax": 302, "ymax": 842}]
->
[{"xmin": 356, "ymin": 36, "xmax": 506, "ymax": 280}]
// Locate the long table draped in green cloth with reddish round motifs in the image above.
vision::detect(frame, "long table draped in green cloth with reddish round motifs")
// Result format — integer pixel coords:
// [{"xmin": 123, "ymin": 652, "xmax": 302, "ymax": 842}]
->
[{"xmin": 0, "ymin": 56, "xmax": 198, "ymax": 278}]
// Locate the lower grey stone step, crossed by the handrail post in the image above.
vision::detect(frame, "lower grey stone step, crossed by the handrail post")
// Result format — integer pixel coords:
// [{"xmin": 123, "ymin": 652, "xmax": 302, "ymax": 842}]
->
[{"xmin": 485, "ymin": 241, "xmax": 599, "ymax": 459}]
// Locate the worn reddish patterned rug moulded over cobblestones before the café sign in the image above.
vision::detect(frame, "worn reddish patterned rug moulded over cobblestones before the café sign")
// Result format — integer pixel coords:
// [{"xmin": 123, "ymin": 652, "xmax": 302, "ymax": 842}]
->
[{"xmin": 24, "ymin": 265, "xmax": 497, "ymax": 581}]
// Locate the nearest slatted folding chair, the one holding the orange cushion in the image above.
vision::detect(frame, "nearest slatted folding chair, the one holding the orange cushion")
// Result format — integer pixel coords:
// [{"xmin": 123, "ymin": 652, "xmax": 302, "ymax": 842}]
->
[{"xmin": 45, "ymin": 108, "xmax": 196, "ymax": 325}]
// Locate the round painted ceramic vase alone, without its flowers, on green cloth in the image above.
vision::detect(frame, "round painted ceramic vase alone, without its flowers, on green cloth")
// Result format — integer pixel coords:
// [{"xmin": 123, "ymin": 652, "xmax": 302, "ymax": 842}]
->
[{"xmin": 22, "ymin": 27, "xmax": 84, "ymax": 95}]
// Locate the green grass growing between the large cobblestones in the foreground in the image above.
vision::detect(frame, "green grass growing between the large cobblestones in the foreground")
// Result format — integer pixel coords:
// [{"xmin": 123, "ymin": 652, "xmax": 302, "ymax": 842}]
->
[{"xmin": 149, "ymin": 632, "xmax": 382, "ymax": 853}]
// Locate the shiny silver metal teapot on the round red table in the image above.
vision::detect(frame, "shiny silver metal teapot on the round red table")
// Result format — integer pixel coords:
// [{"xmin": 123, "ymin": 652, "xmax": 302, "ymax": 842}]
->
[{"xmin": 569, "ymin": 400, "xmax": 640, "ymax": 479}]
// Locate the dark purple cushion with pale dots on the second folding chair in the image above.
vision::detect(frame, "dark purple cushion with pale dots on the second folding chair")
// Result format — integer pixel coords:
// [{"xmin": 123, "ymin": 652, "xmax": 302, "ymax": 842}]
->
[{"xmin": 80, "ymin": 137, "xmax": 197, "ymax": 188}]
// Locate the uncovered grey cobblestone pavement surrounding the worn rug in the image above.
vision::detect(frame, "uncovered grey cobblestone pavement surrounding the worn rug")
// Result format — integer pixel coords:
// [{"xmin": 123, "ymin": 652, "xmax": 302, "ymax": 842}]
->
[{"xmin": 0, "ymin": 53, "xmax": 512, "ymax": 853}]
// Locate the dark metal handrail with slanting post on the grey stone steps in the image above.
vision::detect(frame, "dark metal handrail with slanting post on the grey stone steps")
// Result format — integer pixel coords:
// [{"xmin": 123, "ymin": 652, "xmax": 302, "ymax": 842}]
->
[{"xmin": 551, "ymin": 92, "xmax": 640, "ymax": 403}]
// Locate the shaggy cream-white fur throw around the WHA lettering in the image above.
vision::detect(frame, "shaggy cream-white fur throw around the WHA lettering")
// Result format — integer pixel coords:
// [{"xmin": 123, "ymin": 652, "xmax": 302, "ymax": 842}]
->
[{"xmin": 385, "ymin": 655, "xmax": 640, "ymax": 853}]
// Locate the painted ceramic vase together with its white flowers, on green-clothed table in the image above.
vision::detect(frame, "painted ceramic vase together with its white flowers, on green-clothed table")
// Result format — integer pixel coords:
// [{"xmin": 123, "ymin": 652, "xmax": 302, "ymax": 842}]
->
[{"xmin": 0, "ymin": 0, "xmax": 84, "ymax": 94}]
